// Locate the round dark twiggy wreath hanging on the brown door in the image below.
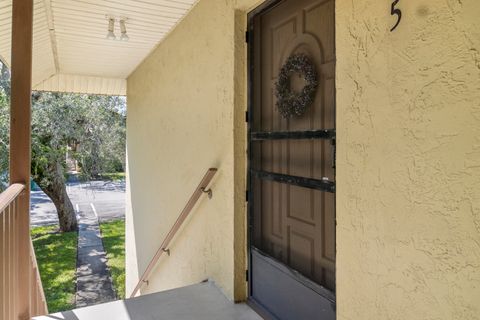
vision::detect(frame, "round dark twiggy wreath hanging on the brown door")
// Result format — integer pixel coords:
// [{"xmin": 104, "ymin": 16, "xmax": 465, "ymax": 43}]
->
[{"xmin": 275, "ymin": 53, "xmax": 318, "ymax": 119}]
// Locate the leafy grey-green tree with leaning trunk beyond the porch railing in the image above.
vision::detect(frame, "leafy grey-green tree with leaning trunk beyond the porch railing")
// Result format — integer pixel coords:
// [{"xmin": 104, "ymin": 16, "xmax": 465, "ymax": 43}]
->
[{"xmin": 0, "ymin": 60, "xmax": 126, "ymax": 231}]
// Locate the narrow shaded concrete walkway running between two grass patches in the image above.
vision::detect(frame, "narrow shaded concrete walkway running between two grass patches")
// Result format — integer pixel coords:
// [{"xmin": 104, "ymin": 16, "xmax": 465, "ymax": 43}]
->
[{"xmin": 75, "ymin": 206, "xmax": 117, "ymax": 307}]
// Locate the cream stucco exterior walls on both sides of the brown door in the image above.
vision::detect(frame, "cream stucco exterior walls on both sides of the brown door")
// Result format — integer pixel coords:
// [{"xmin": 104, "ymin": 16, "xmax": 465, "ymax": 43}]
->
[{"xmin": 127, "ymin": 0, "xmax": 480, "ymax": 320}]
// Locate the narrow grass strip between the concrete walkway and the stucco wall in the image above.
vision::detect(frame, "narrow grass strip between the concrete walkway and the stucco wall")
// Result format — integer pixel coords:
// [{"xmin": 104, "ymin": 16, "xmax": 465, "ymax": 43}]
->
[{"xmin": 100, "ymin": 220, "xmax": 125, "ymax": 299}]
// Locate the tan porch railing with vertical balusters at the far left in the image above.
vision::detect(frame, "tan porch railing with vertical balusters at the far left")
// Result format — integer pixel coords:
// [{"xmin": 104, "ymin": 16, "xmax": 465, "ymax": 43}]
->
[{"xmin": 0, "ymin": 183, "xmax": 48, "ymax": 320}]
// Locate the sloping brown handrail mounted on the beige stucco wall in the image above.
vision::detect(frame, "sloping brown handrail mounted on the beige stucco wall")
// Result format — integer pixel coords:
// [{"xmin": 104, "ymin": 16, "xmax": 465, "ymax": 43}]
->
[{"xmin": 130, "ymin": 168, "xmax": 217, "ymax": 298}]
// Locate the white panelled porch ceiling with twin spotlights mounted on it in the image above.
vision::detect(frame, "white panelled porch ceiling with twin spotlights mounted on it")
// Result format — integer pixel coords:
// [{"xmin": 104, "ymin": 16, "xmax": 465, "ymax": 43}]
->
[{"xmin": 0, "ymin": 0, "xmax": 197, "ymax": 95}]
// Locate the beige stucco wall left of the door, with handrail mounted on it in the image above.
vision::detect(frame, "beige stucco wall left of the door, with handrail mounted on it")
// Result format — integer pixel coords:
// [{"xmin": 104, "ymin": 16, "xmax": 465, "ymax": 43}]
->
[{"xmin": 126, "ymin": 0, "xmax": 259, "ymax": 300}]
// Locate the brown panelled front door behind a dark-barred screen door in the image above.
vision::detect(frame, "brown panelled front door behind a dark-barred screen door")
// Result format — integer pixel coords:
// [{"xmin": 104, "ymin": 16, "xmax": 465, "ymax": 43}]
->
[{"xmin": 249, "ymin": 0, "xmax": 335, "ymax": 319}]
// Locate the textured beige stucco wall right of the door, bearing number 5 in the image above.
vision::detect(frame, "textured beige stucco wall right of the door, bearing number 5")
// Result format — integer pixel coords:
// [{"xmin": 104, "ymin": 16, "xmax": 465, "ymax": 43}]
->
[{"xmin": 336, "ymin": 0, "xmax": 480, "ymax": 320}]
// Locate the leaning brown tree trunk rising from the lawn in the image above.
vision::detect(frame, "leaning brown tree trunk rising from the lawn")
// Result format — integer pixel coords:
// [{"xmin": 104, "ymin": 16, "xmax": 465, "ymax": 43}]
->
[{"xmin": 37, "ymin": 163, "xmax": 77, "ymax": 232}]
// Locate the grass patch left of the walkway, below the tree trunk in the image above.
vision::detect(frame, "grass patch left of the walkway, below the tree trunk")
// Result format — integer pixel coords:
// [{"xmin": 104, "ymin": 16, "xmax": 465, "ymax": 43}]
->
[{"xmin": 31, "ymin": 226, "xmax": 77, "ymax": 313}]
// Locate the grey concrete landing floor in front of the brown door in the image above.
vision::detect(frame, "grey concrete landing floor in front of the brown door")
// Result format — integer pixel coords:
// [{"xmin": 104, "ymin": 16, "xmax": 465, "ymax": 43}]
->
[{"xmin": 33, "ymin": 282, "xmax": 262, "ymax": 320}]
